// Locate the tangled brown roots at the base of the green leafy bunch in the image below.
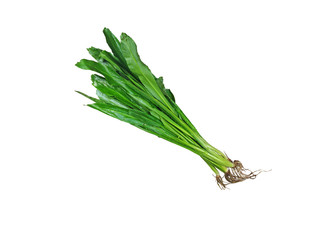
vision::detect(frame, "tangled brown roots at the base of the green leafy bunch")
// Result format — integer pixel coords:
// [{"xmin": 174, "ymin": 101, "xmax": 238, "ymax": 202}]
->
[{"xmin": 216, "ymin": 159, "xmax": 262, "ymax": 189}]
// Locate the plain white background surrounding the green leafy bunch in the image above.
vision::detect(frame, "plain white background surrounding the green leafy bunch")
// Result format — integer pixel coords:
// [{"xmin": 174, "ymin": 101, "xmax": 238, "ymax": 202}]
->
[{"xmin": 0, "ymin": 0, "xmax": 320, "ymax": 240}]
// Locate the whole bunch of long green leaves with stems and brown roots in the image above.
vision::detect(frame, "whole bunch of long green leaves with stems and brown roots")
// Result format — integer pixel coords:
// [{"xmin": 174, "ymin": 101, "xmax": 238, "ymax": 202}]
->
[{"xmin": 76, "ymin": 28, "xmax": 258, "ymax": 189}]
